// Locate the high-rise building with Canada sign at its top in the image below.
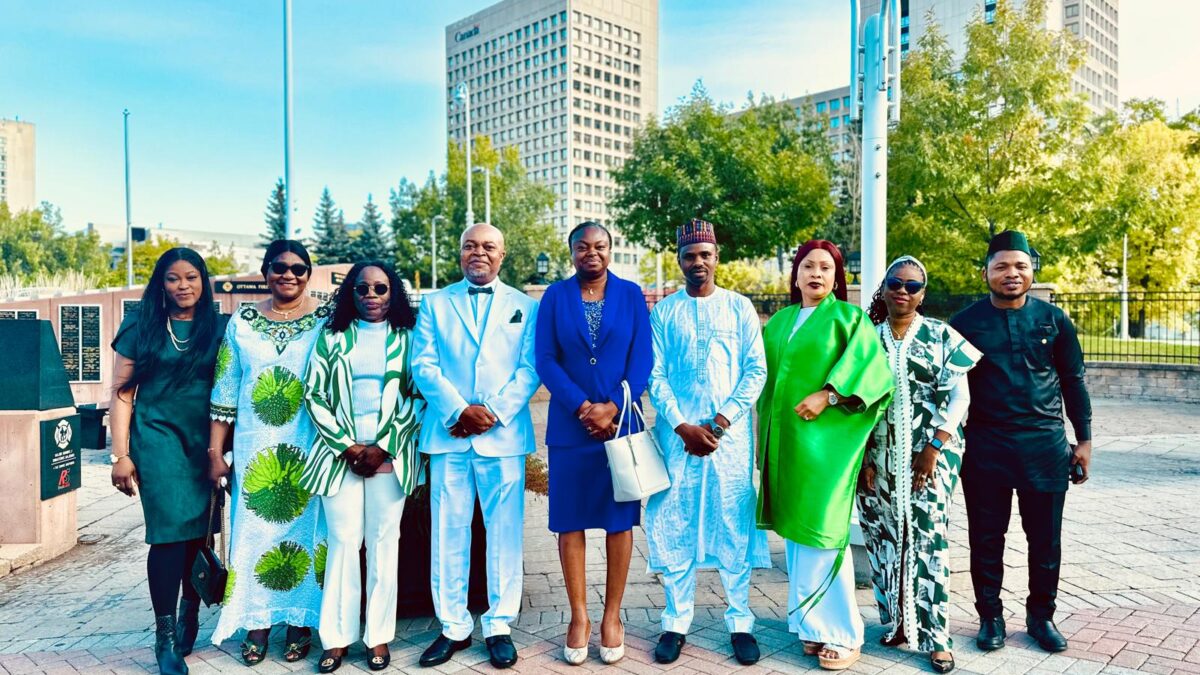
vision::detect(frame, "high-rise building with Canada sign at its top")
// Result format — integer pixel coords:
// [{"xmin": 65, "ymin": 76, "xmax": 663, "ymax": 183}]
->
[{"xmin": 445, "ymin": 0, "xmax": 659, "ymax": 280}]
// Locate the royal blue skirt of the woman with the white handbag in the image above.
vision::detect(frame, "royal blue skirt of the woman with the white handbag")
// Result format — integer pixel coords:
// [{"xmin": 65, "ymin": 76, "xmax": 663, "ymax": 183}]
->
[{"xmin": 548, "ymin": 441, "xmax": 642, "ymax": 533}]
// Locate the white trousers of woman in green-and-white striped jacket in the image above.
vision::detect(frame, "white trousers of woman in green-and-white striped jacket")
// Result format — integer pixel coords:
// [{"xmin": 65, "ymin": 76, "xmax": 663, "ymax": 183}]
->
[{"xmin": 320, "ymin": 471, "xmax": 404, "ymax": 649}]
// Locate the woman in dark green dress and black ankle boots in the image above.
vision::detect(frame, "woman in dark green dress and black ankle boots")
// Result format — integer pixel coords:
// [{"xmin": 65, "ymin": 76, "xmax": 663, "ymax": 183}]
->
[{"xmin": 109, "ymin": 249, "xmax": 228, "ymax": 675}]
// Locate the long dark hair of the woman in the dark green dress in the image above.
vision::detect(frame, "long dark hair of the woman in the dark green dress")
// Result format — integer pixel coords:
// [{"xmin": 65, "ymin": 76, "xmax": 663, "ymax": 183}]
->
[{"xmin": 121, "ymin": 247, "xmax": 221, "ymax": 392}]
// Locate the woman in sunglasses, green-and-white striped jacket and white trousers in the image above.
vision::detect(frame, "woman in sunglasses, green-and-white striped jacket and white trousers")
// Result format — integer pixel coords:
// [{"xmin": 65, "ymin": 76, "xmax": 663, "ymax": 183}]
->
[{"xmin": 300, "ymin": 262, "xmax": 425, "ymax": 673}]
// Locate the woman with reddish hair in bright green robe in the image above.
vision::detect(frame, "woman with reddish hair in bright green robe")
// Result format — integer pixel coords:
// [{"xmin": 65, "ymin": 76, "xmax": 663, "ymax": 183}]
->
[{"xmin": 758, "ymin": 240, "xmax": 893, "ymax": 670}]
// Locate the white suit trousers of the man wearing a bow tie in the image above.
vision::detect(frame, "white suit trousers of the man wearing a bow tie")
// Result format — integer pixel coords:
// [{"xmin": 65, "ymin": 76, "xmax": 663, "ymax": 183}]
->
[{"xmin": 430, "ymin": 448, "xmax": 526, "ymax": 640}]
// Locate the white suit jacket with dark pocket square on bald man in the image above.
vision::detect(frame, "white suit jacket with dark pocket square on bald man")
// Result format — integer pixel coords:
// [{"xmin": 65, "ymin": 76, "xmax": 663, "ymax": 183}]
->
[{"xmin": 413, "ymin": 280, "xmax": 540, "ymax": 458}]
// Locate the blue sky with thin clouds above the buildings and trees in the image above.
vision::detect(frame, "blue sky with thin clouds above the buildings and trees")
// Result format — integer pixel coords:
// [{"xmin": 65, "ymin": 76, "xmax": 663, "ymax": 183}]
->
[{"xmin": 0, "ymin": 0, "xmax": 1200, "ymax": 237}]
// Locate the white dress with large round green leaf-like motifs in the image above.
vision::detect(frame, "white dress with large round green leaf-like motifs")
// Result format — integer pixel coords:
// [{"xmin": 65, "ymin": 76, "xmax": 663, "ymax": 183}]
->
[{"xmin": 210, "ymin": 305, "xmax": 329, "ymax": 645}]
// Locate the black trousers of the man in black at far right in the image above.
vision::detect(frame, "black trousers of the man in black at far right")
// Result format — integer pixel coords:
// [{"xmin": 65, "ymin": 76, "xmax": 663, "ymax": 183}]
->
[{"xmin": 962, "ymin": 479, "xmax": 1067, "ymax": 619}]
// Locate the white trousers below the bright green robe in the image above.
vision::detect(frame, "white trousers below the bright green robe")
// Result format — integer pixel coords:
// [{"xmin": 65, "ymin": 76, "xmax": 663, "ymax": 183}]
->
[{"xmin": 784, "ymin": 539, "xmax": 863, "ymax": 649}]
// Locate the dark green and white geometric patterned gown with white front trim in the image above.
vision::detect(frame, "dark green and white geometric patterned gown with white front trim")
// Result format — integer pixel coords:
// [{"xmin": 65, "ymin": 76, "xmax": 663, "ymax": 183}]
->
[{"xmin": 858, "ymin": 317, "xmax": 983, "ymax": 652}]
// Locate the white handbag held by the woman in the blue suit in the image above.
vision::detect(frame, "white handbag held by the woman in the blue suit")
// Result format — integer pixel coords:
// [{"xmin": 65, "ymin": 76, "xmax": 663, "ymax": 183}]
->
[{"xmin": 604, "ymin": 382, "xmax": 671, "ymax": 502}]
